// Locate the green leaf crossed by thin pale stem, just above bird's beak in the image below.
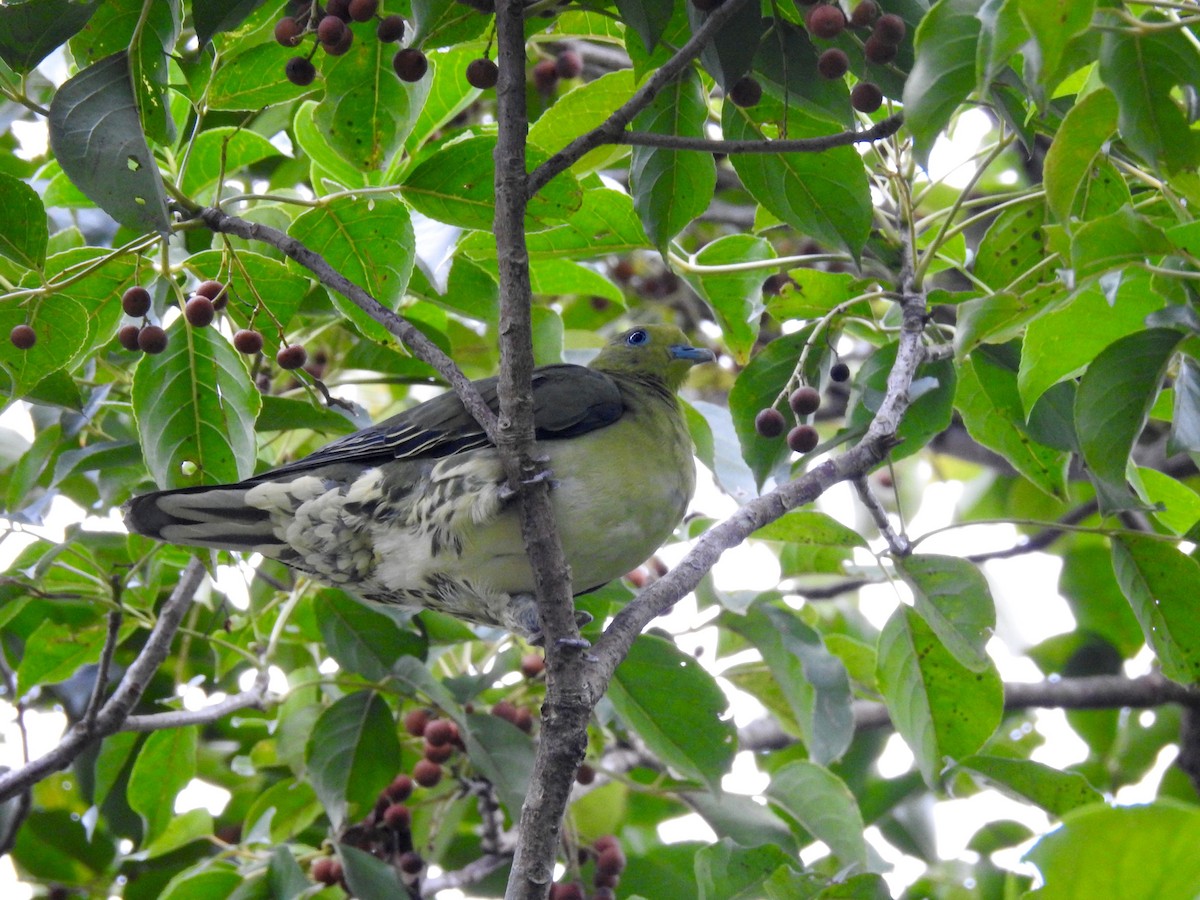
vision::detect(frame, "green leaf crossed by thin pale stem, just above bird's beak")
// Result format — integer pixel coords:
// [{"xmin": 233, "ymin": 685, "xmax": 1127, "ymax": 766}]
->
[{"xmin": 683, "ymin": 234, "xmax": 775, "ymax": 362}]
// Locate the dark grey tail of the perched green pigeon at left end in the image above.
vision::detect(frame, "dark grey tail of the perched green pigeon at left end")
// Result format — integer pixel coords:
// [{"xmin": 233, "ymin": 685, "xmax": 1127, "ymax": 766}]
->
[{"xmin": 125, "ymin": 485, "xmax": 287, "ymax": 557}]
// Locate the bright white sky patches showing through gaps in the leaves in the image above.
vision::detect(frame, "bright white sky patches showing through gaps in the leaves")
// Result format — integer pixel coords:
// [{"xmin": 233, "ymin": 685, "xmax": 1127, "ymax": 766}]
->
[{"xmin": 0, "ymin": 77, "xmax": 1174, "ymax": 900}]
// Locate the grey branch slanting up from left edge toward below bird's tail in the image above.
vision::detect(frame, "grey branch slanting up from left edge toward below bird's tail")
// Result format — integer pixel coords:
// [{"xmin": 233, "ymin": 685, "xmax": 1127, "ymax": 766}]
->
[{"xmin": 0, "ymin": 559, "xmax": 204, "ymax": 802}]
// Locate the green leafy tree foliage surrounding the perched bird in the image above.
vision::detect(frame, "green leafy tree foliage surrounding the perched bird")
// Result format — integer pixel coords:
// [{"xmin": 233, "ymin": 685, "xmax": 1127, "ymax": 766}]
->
[{"xmin": 0, "ymin": 0, "xmax": 1200, "ymax": 898}]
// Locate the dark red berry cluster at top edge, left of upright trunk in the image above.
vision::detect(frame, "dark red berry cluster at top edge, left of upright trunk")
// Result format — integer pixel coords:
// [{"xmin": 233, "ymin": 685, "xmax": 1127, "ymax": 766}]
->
[{"xmin": 275, "ymin": 0, "xmax": 420, "ymax": 88}]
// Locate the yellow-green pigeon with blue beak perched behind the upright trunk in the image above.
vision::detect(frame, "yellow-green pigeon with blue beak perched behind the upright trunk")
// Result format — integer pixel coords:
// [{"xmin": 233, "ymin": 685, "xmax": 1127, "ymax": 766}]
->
[{"xmin": 125, "ymin": 325, "xmax": 714, "ymax": 643}]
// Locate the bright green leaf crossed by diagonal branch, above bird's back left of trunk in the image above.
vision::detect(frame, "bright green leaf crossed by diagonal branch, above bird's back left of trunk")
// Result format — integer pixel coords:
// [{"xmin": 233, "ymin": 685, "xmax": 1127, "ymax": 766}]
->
[{"xmin": 288, "ymin": 194, "xmax": 416, "ymax": 344}]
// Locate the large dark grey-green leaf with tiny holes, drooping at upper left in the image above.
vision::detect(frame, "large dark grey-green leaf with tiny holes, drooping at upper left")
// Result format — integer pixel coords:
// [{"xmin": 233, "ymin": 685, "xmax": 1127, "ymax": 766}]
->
[{"xmin": 49, "ymin": 53, "xmax": 170, "ymax": 235}]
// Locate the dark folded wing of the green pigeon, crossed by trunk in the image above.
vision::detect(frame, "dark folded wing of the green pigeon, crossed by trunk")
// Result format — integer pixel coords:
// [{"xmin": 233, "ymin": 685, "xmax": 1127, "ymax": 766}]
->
[{"xmin": 238, "ymin": 365, "xmax": 624, "ymax": 482}]
